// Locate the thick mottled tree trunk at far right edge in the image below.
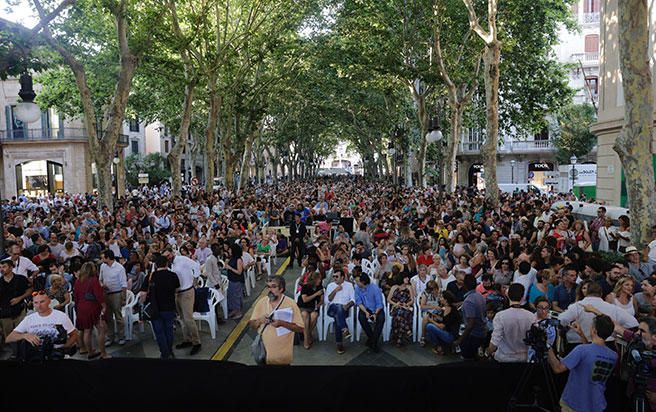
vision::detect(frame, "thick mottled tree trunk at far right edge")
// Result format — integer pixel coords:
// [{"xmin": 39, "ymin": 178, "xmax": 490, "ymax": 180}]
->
[{"xmin": 613, "ymin": 0, "xmax": 656, "ymax": 251}]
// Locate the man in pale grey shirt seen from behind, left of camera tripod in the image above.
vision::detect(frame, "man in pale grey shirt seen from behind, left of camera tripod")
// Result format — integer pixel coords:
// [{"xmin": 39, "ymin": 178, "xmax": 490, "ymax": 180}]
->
[{"xmin": 487, "ymin": 283, "xmax": 535, "ymax": 362}]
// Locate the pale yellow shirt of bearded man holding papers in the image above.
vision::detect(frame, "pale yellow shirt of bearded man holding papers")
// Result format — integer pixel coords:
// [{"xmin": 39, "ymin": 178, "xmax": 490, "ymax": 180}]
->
[{"xmin": 251, "ymin": 296, "xmax": 303, "ymax": 365}]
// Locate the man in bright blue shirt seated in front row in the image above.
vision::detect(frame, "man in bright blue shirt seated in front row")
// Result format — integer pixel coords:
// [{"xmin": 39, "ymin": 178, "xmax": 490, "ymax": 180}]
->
[{"xmin": 355, "ymin": 273, "xmax": 385, "ymax": 352}]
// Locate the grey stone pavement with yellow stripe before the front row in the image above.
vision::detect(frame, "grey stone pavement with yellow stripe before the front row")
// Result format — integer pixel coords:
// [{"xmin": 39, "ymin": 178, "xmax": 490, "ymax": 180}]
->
[{"xmin": 0, "ymin": 258, "xmax": 459, "ymax": 366}]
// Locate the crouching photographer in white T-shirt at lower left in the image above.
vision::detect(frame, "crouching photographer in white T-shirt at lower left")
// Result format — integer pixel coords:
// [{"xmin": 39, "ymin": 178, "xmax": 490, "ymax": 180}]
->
[{"xmin": 7, "ymin": 290, "xmax": 78, "ymax": 362}]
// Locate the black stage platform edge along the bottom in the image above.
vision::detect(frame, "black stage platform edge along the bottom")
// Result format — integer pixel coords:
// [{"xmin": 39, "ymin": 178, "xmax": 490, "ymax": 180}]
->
[{"xmin": 0, "ymin": 359, "xmax": 629, "ymax": 412}]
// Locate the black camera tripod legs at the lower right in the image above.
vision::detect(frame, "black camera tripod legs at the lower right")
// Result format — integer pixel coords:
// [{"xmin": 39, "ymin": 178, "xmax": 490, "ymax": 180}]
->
[{"xmin": 506, "ymin": 353, "xmax": 560, "ymax": 412}]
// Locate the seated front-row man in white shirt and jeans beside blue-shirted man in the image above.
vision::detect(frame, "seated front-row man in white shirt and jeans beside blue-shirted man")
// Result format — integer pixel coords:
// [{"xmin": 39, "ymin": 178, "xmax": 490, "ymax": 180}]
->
[{"xmin": 324, "ymin": 269, "xmax": 355, "ymax": 355}]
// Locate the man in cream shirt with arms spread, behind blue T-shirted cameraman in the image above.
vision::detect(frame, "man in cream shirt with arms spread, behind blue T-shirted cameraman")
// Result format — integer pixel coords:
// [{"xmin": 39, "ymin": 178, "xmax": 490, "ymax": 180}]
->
[{"xmin": 558, "ymin": 282, "xmax": 638, "ymax": 344}]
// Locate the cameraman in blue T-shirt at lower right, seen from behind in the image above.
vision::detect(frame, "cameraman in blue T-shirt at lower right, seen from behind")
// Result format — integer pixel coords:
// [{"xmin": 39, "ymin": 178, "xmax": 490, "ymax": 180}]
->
[{"xmin": 548, "ymin": 315, "xmax": 617, "ymax": 412}]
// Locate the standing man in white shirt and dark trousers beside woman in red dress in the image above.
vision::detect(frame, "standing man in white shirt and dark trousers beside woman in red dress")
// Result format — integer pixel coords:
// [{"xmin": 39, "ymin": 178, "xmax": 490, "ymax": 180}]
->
[{"xmin": 98, "ymin": 249, "xmax": 128, "ymax": 346}]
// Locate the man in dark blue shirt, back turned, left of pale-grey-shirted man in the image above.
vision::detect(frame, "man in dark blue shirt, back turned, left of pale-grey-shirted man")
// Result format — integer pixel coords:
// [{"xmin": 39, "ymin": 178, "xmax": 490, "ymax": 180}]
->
[{"xmin": 454, "ymin": 274, "xmax": 487, "ymax": 360}]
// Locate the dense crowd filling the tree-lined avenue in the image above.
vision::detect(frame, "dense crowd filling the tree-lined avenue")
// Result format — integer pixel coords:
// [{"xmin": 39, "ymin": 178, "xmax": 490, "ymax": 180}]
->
[{"xmin": 0, "ymin": 178, "xmax": 656, "ymax": 410}]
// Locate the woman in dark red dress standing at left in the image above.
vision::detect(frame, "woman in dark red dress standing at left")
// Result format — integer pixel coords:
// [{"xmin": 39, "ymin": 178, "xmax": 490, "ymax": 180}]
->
[{"xmin": 73, "ymin": 262, "xmax": 109, "ymax": 359}]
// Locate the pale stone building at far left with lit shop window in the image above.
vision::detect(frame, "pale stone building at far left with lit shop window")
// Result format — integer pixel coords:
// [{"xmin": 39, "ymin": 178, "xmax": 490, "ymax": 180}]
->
[{"xmin": 0, "ymin": 78, "xmax": 151, "ymax": 199}]
